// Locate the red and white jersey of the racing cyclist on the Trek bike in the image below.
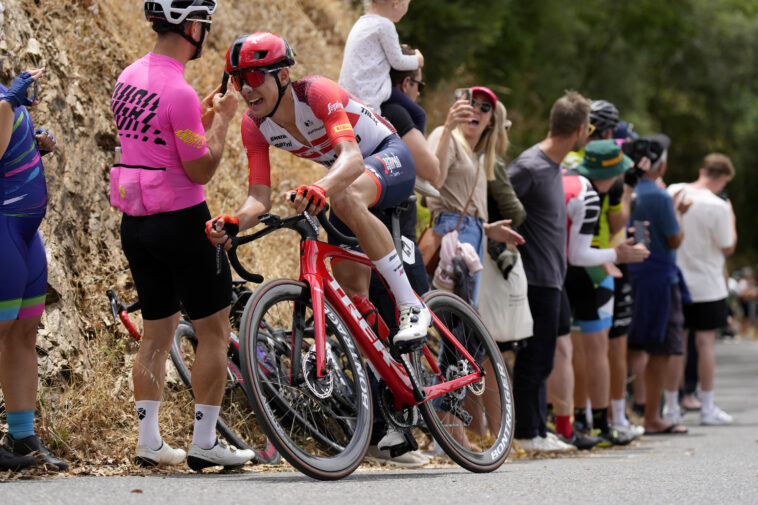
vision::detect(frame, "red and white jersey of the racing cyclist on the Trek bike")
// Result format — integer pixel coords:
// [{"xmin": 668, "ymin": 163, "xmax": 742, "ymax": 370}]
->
[{"xmin": 242, "ymin": 75, "xmax": 395, "ymax": 186}]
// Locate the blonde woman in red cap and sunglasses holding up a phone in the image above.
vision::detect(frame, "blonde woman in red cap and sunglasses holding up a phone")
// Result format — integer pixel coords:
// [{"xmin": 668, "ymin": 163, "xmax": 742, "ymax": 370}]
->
[{"xmin": 427, "ymin": 86, "xmax": 523, "ymax": 307}]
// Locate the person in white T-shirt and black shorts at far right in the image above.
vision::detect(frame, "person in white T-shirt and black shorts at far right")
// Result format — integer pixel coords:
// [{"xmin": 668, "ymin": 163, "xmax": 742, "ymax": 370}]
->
[{"xmin": 664, "ymin": 153, "xmax": 737, "ymax": 425}]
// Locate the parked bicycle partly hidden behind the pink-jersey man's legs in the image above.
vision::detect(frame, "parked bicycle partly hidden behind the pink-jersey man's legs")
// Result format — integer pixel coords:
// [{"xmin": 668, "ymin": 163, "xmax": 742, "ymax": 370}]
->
[{"xmin": 106, "ymin": 280, "xmax": 281, "ymax": 464}]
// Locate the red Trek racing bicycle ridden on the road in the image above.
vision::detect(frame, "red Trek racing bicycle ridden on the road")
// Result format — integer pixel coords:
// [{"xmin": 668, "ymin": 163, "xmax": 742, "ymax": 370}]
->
[{"xmin": 228, "ymin": 207, "xmax": 513, "ymax": 480}]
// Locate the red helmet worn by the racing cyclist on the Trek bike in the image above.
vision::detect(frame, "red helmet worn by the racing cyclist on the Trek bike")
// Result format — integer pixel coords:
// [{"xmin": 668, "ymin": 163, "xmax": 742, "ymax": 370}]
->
[{"xmin": 225, "ymin": 32, "xmax": 295, "ymax": 75}]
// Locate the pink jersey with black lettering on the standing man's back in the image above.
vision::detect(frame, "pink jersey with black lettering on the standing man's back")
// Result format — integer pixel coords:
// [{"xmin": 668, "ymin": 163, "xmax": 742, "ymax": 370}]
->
[{"xmin": 111, "ymin": 53, "xmax": 208, "ymax": 210}]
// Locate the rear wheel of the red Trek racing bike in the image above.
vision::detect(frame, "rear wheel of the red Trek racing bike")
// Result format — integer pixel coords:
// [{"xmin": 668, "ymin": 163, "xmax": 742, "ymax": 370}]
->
[{"xmin": 413, "ymin": 291, "xmax": 514, "ymax": 472}]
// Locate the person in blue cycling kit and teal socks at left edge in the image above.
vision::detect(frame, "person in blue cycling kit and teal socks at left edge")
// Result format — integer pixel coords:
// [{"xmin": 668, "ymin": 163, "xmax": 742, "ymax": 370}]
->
[{"xmin": 0, "ymin": 28, "xmax": 68, "ymax": 471}]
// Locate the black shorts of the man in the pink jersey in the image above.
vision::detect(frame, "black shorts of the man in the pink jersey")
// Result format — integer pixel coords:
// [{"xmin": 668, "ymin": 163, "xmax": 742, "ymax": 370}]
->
[{"xmin": 121, "ymin": 202, "xmax": 232, "ymax": 320}]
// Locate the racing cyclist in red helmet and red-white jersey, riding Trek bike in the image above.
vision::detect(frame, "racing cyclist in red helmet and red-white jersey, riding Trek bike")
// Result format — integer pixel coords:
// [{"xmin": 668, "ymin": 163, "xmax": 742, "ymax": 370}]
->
[{"xmin": 206, "ymin": 32, "xmax": 431, "ymax": 350}]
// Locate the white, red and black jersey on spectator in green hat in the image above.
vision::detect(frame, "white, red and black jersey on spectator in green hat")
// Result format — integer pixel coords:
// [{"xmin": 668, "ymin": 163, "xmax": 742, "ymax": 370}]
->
[{"xmin": 563, "ymin": 169, "xmax": 616, "ymax": 266}]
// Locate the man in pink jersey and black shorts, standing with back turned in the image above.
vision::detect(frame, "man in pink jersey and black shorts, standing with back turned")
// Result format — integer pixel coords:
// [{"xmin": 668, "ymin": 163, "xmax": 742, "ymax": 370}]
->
[{"xmin": 111, "ymin": 0, "xmax": 253, "ymax": 470}]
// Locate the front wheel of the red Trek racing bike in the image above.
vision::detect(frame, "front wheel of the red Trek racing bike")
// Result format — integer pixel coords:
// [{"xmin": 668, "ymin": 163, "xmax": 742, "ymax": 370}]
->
[{"xmin": 240, "ymin": 279, "xmax": 372, "ymax": 480}]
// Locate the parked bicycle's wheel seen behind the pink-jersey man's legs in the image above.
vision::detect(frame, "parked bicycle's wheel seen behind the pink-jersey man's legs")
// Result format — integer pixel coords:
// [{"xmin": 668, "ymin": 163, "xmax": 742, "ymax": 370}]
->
[{"xmin": 170, "ymin": 321, "xmax": 281, "ymax": 464}]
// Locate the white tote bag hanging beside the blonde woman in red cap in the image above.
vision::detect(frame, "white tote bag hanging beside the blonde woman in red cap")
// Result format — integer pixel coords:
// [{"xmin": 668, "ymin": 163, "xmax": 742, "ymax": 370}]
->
[{"xmin": 479, "ymin": 250, "xmax": 533, "ymax": 342}]
